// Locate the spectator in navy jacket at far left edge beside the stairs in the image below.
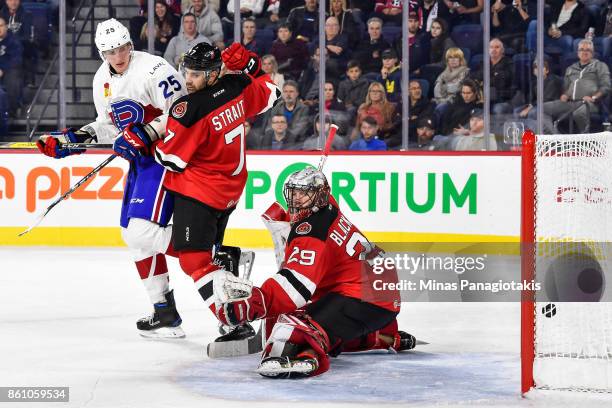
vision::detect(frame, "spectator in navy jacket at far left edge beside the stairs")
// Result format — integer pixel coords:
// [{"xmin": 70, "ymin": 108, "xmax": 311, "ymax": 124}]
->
[{"xmin": 0, "ymin": 17, "xmax": 23, "ymax": 117}]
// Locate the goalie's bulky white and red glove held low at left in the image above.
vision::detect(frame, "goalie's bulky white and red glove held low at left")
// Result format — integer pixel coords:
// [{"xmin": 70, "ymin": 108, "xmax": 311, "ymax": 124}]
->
[{"xmin": 213, "ymin": 271, "xmax": 266, "ymax": 326}]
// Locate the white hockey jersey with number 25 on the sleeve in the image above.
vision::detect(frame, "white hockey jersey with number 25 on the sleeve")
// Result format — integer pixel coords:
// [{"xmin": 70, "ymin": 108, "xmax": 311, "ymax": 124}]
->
[{"xmin": 82, "ymin": 51, "xmax": 187, "ymax": 143}]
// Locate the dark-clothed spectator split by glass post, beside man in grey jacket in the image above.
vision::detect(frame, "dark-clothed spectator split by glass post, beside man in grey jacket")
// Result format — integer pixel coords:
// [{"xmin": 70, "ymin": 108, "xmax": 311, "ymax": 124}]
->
[{"xmin": 512, "ymin": 59, "xmax": 563, "ymax": 120}]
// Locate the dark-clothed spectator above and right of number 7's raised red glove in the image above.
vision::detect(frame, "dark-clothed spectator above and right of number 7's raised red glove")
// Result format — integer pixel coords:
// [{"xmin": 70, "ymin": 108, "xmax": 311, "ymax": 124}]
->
[{"xmin": 270, "ymin": 23, "xmax": 309, "ymax": 79}]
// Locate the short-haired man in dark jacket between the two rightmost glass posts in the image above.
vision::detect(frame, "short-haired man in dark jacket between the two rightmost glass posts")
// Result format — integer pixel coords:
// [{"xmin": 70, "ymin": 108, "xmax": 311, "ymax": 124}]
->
[{"xmin": 470, "ymin": 38, "xmax": 516, "ymax": 114}]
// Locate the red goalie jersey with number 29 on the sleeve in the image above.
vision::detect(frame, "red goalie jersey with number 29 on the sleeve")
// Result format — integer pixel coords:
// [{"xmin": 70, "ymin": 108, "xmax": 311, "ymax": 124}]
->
[{"xmin": 261, "ymin": 199, "xmax": 400, "ymax": 316}]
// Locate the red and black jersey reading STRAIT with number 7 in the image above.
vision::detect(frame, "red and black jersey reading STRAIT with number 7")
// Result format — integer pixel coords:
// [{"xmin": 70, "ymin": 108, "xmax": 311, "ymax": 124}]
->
[{"xmin": 155, "ymin": 73, "xmax": 280, "ymax": 210}]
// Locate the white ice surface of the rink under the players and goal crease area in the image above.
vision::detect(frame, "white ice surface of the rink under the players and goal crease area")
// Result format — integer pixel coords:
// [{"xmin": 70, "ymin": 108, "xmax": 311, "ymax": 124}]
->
[{"xmin": 0, "ymin": 248, "xmax": 612, "ymax": 408}]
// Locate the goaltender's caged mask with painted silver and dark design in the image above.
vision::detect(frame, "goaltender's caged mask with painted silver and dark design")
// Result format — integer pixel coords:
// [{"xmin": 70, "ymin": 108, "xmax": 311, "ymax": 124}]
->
[{"xmin": 283, "ymin": 167, "xmax": 329, "ymax": 224}]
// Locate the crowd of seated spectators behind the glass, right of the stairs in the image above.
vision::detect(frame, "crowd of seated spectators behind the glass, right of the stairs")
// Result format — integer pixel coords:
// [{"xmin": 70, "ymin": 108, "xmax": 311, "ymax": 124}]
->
[{"xmin": 125, "ymin": 0, "xmax": 612, "ymax": 150}]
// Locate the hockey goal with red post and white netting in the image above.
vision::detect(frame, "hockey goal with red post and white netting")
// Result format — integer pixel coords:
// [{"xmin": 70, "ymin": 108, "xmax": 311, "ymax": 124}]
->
[{"xmin": 521, "ymin": 131, "xmax": 612, "ymax": 392}]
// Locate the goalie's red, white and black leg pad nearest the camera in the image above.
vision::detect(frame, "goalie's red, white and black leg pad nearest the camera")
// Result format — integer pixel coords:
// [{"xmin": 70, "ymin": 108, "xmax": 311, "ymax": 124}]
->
[{"xmin": 261, "ymin": 312, "xmax": 329, "ymax": 376}]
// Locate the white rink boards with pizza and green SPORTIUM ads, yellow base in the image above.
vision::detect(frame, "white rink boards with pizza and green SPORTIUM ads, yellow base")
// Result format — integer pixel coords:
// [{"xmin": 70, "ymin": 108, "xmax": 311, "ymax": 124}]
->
[{"xmin": 0, "ymin": 152, "xmax": 520, "ymax": 247}]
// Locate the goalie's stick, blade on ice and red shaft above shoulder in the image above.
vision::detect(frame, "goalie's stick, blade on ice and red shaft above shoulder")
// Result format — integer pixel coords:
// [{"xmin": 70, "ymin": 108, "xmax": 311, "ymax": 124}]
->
[{"xmin": 206, "ymin": 124, "xmax": 338, "ymax": 358}]
